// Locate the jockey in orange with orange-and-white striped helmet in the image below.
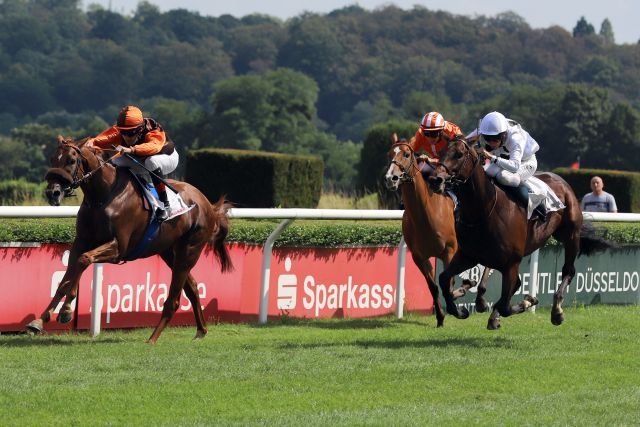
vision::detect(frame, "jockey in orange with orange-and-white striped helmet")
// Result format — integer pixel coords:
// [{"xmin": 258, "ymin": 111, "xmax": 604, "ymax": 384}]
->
[{"xmin": 409, "ymin": 111, "xmax": 464, "ymax": 177}]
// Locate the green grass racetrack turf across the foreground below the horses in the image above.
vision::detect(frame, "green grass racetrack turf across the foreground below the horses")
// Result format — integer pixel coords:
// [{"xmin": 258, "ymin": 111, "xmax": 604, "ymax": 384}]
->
[{"xmin": 0, "ymin": 306, "xmax": 640, "ymax": 426}]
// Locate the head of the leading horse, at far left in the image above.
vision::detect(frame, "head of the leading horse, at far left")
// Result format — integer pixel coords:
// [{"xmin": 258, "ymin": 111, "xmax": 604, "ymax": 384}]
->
[{"xmin": 44, "ymin": 135, "xmax": 82, "ymax": 206}]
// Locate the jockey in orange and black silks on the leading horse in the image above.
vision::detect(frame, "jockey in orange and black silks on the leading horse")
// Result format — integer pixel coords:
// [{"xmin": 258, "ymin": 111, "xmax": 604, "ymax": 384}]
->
[{"xmin": 87, "ymin": 105, "xmax": 179, "ymax": 222}]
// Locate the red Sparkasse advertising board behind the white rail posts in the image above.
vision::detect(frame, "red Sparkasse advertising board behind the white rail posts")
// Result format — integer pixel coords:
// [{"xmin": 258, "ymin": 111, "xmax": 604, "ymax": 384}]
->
[{"xmin": 0, "ymin": 244, "xmax": 433, "ymax": 331}]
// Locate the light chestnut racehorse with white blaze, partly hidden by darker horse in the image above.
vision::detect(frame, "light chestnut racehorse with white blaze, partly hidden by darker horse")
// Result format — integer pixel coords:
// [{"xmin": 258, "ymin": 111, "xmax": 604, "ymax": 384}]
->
[{"xmin": 385, "ymin": 134, "xmax": 489, "ymax": 327}]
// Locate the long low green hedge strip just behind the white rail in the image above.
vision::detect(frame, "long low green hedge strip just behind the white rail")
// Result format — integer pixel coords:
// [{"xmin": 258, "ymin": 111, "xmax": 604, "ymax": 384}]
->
[{"xmin": 0, "ymin": 218, "xmax": 640, "ymax": 247}]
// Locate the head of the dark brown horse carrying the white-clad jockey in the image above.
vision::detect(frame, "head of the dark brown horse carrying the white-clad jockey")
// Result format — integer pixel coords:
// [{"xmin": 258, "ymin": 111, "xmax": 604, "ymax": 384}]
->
[{"xmin": 429, "ymin": 138, "xmax": 478, "ymax": 193}]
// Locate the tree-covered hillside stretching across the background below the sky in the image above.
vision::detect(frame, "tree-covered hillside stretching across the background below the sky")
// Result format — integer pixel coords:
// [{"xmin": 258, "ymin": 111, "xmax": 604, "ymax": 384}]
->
[{"xmin": 0, "ymin": 0, "xmax": 640, "ymax": 190}]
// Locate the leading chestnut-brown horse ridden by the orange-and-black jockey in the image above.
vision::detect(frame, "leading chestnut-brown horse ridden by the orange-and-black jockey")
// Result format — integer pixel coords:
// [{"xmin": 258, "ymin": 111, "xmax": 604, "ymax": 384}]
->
[{"xmin": 27, "ymin": 136, "xmax": 233, "ymax": 343}]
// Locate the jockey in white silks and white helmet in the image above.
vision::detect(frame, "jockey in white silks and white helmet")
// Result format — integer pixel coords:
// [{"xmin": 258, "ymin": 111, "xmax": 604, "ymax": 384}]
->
[{"xmin": 467, "ymin": 111, "xmax": 542, "ymax": 217}]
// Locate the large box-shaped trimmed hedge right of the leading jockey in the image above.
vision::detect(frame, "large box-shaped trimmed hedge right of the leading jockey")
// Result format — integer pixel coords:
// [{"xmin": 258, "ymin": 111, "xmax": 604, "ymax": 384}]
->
[{"xmin": 186, "ymin": 148, "xmax": 324, "ymax": 208}]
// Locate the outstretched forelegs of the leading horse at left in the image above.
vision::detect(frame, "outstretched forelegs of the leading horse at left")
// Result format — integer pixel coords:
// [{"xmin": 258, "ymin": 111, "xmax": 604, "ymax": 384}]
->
[{"xmin": 27, "ymin": 239, "xmax": 119, "ymax": 333}]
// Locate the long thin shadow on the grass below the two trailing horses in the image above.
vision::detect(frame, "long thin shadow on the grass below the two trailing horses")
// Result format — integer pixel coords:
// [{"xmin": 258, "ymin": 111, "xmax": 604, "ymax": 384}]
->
[{"xmin": 279, "ymin": 337, "xmax": 514, "ymax": 350}]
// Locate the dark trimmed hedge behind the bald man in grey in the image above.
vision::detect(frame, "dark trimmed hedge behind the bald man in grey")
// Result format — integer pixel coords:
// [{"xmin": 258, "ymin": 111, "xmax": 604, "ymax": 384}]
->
[{"xmin": 553, "ymin": 168, "xmax": 640, "ymax": 212}]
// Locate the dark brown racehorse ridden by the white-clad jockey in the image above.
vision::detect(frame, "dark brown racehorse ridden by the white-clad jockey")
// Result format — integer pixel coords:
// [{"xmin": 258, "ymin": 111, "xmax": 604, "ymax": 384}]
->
[{"xmin": 429, "ymin": 139, "xmax": 613, "ymax": 329}]
